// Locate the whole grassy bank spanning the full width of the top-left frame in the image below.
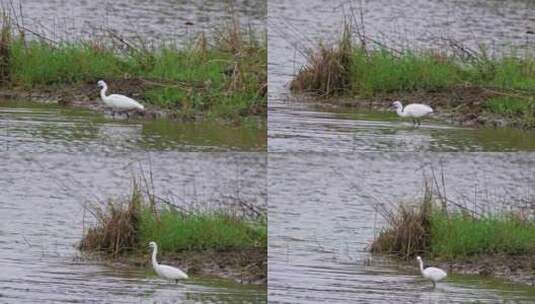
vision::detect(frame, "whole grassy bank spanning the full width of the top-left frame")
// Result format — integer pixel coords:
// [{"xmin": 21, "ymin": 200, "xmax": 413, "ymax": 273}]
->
[{"xmin": 0, "ymin": 16, "xmax": 267, "ymax": 121}]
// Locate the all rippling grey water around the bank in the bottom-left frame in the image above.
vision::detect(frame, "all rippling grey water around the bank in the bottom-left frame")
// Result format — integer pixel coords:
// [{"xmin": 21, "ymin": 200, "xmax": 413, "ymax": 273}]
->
[{"xmin": 0, "ymin": 151, "xmax": 267, "ymax": 303}]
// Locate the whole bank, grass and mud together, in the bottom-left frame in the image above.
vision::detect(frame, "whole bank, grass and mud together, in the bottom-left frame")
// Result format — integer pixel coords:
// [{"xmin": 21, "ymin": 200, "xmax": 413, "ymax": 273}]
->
[{"xmin": 79, "ymin": 186, "xmax": 267, "ymax": 284}]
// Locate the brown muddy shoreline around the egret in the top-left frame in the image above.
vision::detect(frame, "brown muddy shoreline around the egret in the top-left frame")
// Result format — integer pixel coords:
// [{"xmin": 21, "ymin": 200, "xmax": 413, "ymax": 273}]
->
[{"xmin": 0, "ymin": 79, "xmax": 262, "ymax": 124}]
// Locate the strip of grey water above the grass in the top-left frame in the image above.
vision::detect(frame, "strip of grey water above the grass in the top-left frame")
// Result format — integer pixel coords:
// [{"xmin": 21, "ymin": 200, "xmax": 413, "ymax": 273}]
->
[{"xmin": 11, "ymin": 0, "xmax": 267, "ymax": 42}]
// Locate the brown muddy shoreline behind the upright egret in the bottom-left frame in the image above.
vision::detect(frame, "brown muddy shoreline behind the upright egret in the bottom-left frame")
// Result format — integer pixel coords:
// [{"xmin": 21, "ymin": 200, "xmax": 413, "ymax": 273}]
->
[{"xmin": 82, "ymin": 248, "xmax": 267, "ymax": 286}]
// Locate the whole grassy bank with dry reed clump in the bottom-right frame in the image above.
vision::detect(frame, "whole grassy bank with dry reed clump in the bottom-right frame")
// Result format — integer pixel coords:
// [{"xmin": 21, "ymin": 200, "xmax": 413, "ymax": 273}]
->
[{"xmin": 371, "ymin": 186, "xmax": 535, "ymax": 284}]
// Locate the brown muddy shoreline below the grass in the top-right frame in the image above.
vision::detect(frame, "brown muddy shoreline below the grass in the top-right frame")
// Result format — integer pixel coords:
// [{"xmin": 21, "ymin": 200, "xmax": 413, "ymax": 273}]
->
[{"xmin": 289, "ymin": 87, "xmax": 525, "ymax": 128}]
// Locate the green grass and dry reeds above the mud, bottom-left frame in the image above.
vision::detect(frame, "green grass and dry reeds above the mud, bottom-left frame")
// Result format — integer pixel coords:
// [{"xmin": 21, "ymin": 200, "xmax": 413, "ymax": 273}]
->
[{"xmin": 79, "ymin": 180, "xmax": 267, "ymax": 256}]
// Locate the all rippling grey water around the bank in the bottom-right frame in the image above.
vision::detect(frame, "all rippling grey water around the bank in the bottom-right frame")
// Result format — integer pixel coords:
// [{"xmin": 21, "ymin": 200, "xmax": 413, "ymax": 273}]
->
[{"xmin": 268, "ymin": 153, "xmax": 535, "ymax": 303}]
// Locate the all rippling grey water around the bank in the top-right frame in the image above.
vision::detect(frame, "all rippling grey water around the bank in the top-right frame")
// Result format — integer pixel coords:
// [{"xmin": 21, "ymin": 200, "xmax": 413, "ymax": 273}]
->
[{"xmin": 268, "ymin": 0, "xmax": 535, "ymax": 152}]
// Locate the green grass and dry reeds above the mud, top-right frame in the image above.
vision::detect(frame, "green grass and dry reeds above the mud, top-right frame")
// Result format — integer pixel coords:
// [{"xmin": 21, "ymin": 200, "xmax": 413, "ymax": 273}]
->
[{"xmin": 291, "ymin": 25, "xmax": 535, "ymax": 96}]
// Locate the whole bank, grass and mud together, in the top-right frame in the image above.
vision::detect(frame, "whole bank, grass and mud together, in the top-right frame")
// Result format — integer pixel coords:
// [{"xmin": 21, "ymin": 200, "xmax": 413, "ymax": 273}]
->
[{"xmin": 291, "ymin": 25, "xmax": 535, "ymax": 127}]
